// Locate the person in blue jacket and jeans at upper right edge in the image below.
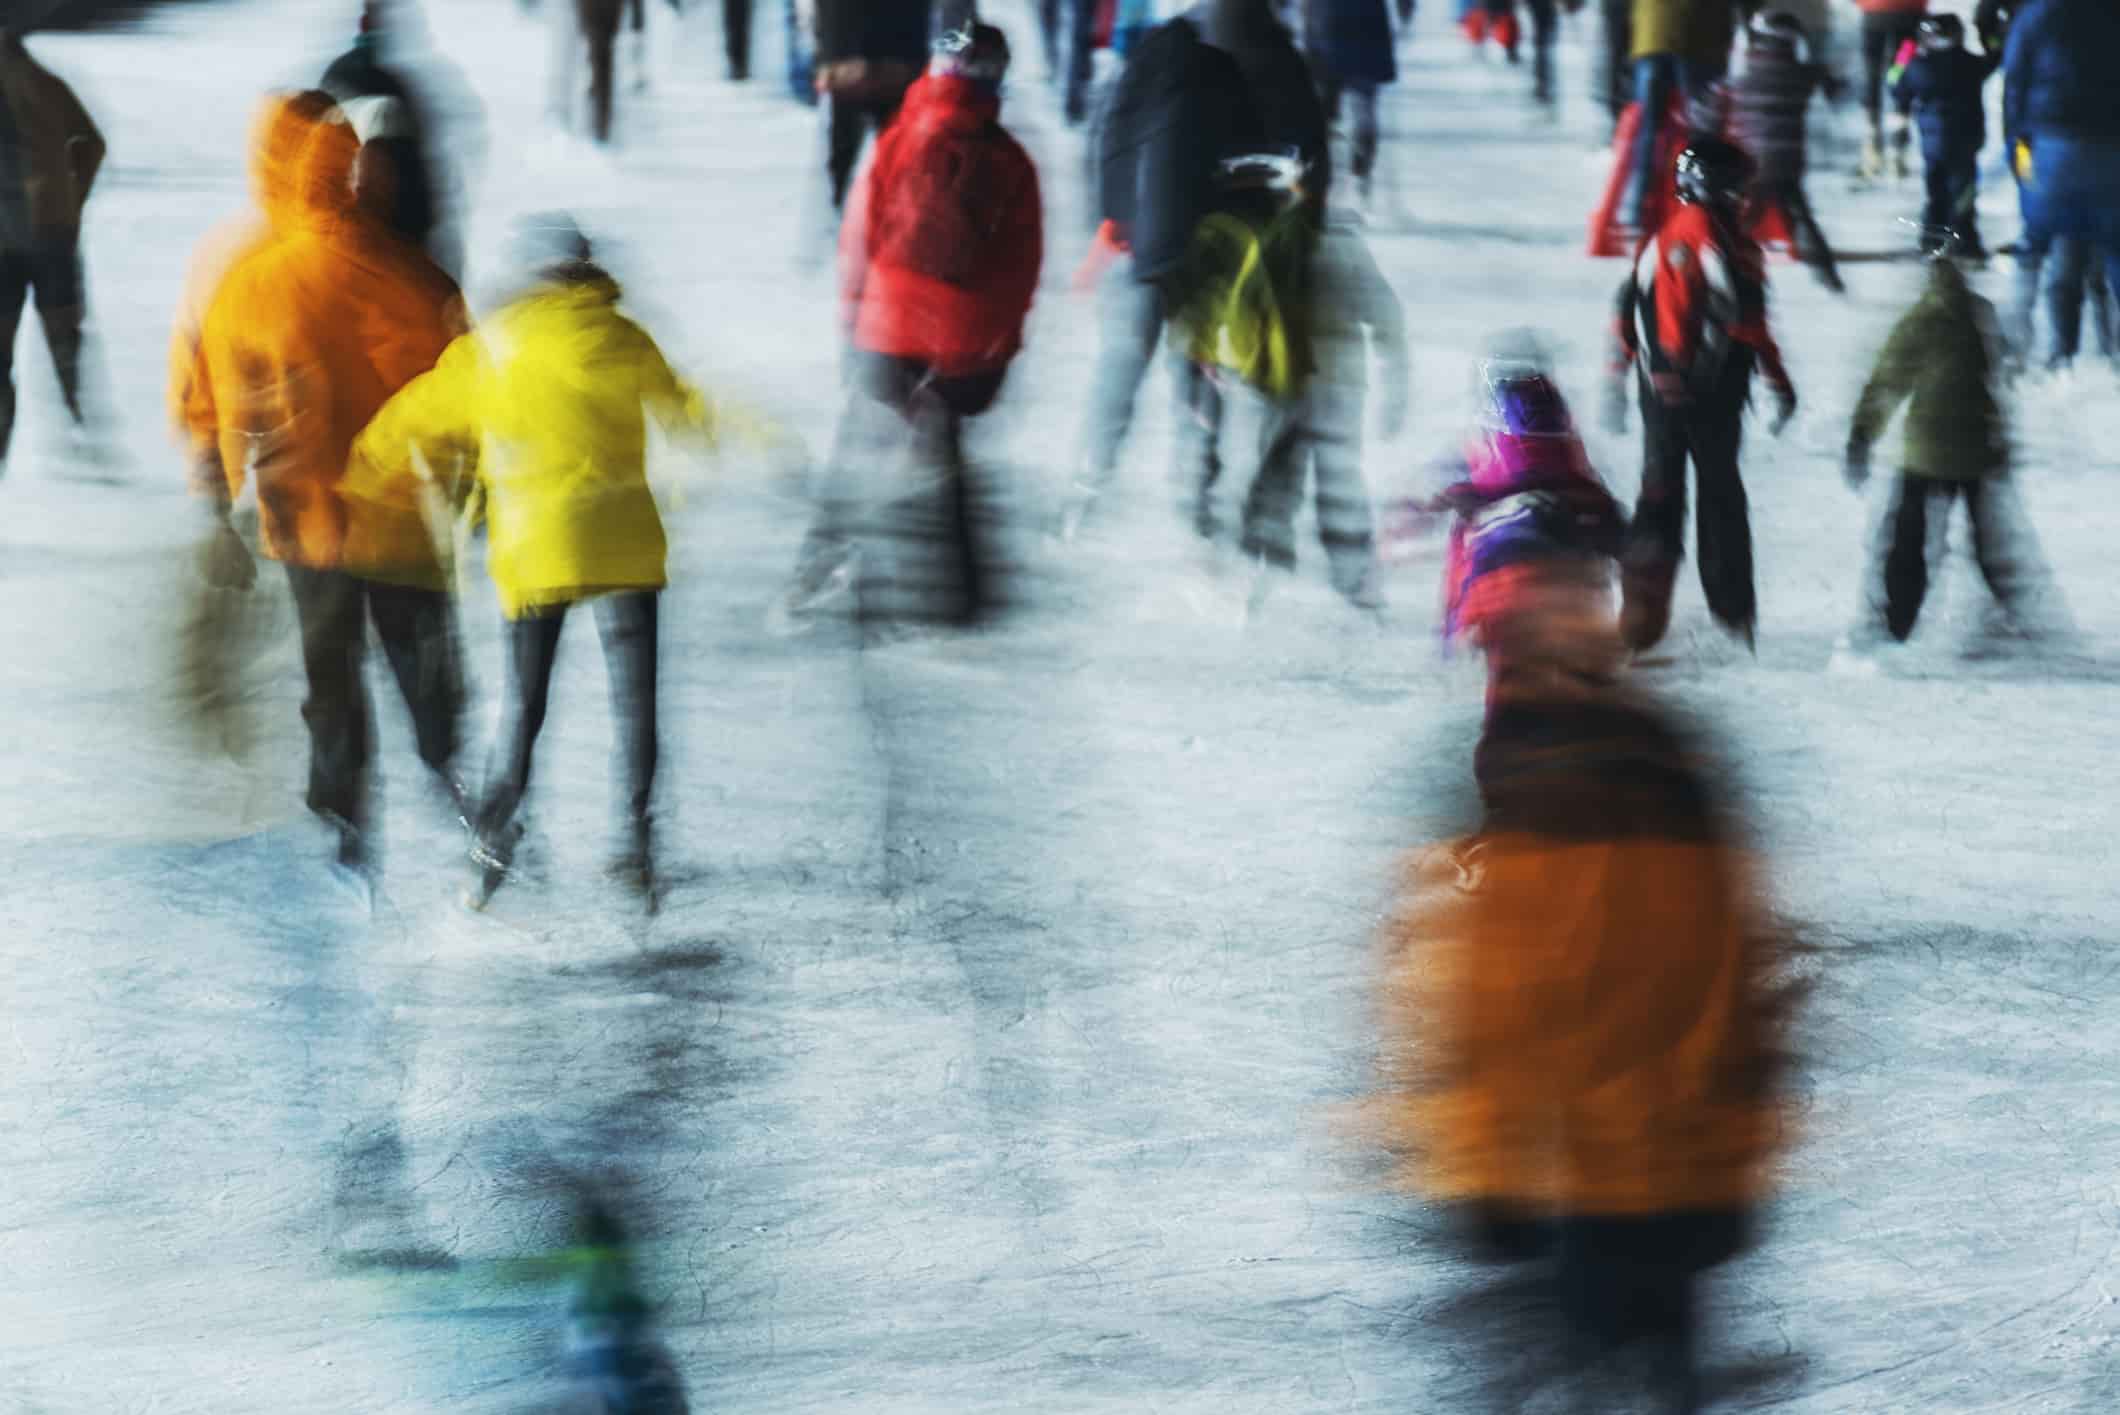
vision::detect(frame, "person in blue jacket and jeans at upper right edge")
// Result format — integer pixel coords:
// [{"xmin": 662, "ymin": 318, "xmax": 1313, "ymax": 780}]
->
[{"xmin": 2001, "ymin": 0, "xmax": 2120, "ymax": 371}]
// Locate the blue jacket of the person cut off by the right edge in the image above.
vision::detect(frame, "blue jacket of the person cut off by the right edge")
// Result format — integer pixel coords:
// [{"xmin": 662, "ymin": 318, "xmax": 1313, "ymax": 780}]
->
[{"xmin": 2001, "ymin": 0, "xmax": 2120, "ymax": 149}]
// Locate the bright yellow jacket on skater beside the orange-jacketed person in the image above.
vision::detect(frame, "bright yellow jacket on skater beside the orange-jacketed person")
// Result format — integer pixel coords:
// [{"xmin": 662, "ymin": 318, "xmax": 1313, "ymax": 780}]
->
[{"xmin": 348, "ymin": 275, "xmax": 717, "ymax": 619}]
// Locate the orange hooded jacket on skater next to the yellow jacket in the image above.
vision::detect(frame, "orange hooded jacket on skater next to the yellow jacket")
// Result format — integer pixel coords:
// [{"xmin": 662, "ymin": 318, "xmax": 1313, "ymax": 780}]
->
[{"xmin": 184, "ymin": 103, "xmax": 464, "ymax": 590}]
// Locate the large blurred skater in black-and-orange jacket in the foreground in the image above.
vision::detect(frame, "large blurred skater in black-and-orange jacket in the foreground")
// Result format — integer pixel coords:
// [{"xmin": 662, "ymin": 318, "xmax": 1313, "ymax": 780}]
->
[{"xmin": 1374, "ymin": 536, "xmax": 1787, "ymax": 1413}]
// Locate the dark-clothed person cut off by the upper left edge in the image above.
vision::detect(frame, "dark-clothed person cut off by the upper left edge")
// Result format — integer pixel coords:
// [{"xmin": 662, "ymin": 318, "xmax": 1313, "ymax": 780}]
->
[{"xmin": 0, "ymin": 25, "xmax": 104, "ymax": 462}]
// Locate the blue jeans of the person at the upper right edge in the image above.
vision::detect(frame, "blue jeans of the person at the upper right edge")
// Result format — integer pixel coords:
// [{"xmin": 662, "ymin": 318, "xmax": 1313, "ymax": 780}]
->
[{"xmin": 2010, "ymin": 134, "xmax": 2120, "ymax": 359}]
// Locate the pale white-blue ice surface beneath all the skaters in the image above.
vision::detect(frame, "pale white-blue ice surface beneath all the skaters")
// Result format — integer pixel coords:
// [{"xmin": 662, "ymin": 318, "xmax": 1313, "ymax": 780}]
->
[{"xmin": 0, "ymin": 0, "xmax": 2120, "ymax": 1415}]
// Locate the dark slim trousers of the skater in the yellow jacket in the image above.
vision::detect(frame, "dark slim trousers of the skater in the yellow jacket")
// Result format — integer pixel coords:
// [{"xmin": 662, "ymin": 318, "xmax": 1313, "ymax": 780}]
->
[{"xmin": 475, "ymin": 590, "xmax": 657, "ymax": 863}]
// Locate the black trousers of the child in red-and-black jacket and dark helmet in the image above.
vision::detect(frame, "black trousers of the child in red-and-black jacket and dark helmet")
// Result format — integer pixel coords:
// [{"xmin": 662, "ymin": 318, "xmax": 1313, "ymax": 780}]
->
[{"xmin": 1620, "ymin": 388, "xmax": 1757, "ymax": 649}]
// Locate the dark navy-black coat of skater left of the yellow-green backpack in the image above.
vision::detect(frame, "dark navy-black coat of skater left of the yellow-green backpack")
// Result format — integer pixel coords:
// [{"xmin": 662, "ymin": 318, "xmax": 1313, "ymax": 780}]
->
[{"xmin": 1098, "ymin": 19, "xmax": 1263, "ymax": 282}]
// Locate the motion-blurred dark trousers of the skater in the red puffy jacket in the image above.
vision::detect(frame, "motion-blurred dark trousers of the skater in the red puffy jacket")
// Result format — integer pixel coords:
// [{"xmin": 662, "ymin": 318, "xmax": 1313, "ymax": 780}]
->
[{"xmin": 797, "ymin": 352, "xmax": 1005, "ymax": 624}]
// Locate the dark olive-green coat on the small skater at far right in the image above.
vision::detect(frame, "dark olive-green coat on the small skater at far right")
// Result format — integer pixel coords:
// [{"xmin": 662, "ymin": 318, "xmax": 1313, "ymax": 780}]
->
[{"xmin": 1849, "ymin": 263, "xmax": 2010, "ymax": 482}]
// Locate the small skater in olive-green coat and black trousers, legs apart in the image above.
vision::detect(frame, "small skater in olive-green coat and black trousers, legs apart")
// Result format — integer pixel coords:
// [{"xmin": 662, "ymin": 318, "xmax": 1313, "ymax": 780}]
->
[{"xmin": 1847, "ymin": 257, "xmax": 2029, "ymax": 662}]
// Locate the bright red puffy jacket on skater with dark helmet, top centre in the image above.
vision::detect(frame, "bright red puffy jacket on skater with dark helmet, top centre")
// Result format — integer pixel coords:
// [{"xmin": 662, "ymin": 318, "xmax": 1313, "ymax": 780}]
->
[{"xmin": 840, "ymin": 74, "xmax": 1045, "ymax": 378}]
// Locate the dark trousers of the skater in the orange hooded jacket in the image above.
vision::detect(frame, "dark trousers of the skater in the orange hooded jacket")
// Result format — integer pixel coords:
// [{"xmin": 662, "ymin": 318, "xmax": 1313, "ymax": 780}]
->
[{"xmin": 286, "ymin": 564, "xmax": 464, "ymax": 829}]
